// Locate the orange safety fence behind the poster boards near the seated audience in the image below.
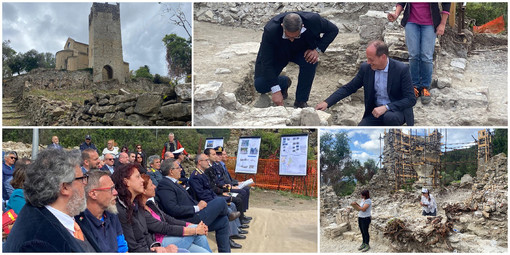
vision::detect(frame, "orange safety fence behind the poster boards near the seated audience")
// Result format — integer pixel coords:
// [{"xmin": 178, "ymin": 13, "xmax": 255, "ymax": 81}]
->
[{"xmin": 226, "ymin": 157, "xmax": 318, "ymax": 197}]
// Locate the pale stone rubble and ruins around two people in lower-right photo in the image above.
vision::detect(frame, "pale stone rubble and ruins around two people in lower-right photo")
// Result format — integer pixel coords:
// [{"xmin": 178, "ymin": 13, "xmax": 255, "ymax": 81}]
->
[{"xmin": 320, "ymin": 154, "xmax": 508, "ymax": 252}]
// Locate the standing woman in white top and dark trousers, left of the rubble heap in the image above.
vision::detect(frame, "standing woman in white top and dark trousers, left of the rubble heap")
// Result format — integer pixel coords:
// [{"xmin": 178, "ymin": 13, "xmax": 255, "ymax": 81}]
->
[{"xmin": 351, "ymin": 190, "xmax": 372, "ymax": 252}]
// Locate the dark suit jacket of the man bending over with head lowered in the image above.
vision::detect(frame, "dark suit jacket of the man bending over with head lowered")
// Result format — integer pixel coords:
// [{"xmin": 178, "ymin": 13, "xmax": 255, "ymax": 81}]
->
[{"xmin": 255, "ymin": 12, "xmax": 338, "ymax": 86}]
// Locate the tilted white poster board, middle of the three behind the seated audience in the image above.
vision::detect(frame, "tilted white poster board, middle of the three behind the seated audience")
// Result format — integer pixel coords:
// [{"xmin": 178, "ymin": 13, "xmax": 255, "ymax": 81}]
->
[{"xmin": 235, "ymin": 136, "xmax": 261, "ymax": 174}]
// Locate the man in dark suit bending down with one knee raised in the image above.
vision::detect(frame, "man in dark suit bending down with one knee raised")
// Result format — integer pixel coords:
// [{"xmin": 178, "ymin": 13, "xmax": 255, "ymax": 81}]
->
[{"xmin": 255, "ymin": 12, "xmax": 338, "ymax": 108}]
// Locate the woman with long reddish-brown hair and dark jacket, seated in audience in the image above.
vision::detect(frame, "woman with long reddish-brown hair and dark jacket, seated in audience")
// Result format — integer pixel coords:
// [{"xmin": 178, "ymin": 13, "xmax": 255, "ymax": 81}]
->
[{"xmin": 112, "ymin": 163, "xmax": 181, "ymax": 253}]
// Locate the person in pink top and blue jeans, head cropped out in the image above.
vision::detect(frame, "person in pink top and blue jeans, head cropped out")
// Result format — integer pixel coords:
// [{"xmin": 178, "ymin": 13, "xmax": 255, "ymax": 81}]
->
[{"xmin": 388, "ymin": 3, "xmax": 451, "ymax": 104}]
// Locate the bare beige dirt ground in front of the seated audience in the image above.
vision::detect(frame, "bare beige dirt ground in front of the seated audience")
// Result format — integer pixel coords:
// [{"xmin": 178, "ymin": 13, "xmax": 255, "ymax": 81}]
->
[{"xmin": 208, "ymin": 189, "xmax": 318, "ymax": 253}]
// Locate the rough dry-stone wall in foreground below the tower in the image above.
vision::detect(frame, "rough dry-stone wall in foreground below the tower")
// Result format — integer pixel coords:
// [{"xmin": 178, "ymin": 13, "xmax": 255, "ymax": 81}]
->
[{"xmin": 18, "ymin": 83, "xmax": 191, "ymax": 126}]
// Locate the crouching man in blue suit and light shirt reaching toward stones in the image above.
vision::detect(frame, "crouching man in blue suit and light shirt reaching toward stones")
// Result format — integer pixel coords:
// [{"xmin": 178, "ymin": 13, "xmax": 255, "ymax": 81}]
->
[{"xmin": 315, "ymin": 41, "xmax": 416, "ymax": 126}]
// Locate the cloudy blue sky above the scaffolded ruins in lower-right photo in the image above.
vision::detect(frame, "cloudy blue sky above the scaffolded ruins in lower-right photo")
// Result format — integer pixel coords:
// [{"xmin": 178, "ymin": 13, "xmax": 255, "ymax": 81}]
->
[{"xmin": 320, "ymin": 128, "xmax": 481, "ymax": 163}]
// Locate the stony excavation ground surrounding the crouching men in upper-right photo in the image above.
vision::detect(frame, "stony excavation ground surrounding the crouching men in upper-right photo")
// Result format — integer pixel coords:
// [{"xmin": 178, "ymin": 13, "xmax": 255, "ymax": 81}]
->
[{"xmin": 193, "ymin": 3, "xmax": 508, "ymax": 126}]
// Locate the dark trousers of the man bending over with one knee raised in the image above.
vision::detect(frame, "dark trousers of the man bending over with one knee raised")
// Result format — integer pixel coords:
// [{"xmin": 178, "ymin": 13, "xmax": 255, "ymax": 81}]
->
[{"xmin": 255, "ymin": 52, "xmax": 318, "ymax": 102}]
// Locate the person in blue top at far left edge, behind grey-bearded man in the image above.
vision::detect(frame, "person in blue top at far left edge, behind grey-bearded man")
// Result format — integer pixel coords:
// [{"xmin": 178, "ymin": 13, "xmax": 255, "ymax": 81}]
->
[{"xmin": 6, "ymin": 158, "xmax": 31, "ymax": 214}]
